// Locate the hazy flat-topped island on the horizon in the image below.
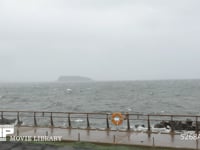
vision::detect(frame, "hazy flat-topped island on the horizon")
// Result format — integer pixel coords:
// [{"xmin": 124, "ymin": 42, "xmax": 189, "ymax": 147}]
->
[{"xmin": 58, "ymin": 76, "xmax": 93, "ymax": 82}]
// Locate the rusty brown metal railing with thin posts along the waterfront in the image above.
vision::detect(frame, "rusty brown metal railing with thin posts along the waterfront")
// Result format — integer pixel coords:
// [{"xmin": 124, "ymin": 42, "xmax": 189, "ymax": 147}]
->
[{"xmin": 0, "ymin": 110, "xmax": 200, "ymax": 134}]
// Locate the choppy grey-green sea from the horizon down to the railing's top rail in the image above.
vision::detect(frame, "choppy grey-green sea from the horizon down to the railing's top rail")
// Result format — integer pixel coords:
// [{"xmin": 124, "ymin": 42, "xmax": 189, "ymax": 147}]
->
[{"xmin": 0, "ymin": 80, "xmax": 200, "ymax": 115}]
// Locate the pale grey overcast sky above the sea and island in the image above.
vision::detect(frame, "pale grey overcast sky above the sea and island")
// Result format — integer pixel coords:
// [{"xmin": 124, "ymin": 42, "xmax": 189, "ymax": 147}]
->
[{"xmin": 0, "ymin": 0, "xmax": 200, "ymax": 81}]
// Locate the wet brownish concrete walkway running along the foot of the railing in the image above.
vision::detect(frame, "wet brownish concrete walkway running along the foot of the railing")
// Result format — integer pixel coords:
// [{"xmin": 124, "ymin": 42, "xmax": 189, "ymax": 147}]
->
[{"xmin": 2, "ymin": 127, "xmax": 199, "ymax": 150}]
